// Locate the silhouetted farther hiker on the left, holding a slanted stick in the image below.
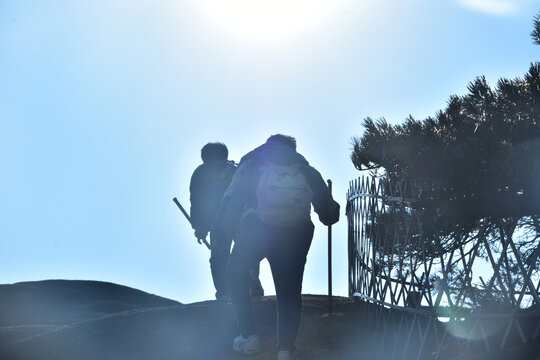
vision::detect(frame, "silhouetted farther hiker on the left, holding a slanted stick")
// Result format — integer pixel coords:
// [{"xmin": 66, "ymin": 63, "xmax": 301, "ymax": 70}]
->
[{"xmin": 189, "ymin": 143, "xmax": 264, "ymax": 301}]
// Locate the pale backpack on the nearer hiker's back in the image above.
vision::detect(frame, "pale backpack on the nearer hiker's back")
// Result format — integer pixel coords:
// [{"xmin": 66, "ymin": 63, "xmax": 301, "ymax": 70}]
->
[{"xmin": 255, "ymin": 163, "xmax": 313, "ymax": 227}]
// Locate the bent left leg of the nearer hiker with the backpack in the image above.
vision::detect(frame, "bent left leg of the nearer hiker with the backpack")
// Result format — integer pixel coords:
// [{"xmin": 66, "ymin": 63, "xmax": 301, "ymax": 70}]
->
[{"xmin": 227, "ymin": 216, "xmax": 266, "ymax": 337}]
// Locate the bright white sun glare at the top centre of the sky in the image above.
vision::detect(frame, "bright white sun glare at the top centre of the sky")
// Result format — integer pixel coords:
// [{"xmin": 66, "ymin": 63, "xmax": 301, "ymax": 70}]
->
[{"xmin": 189, "ymin": 0, "xmax": 350, "ymax": 42}]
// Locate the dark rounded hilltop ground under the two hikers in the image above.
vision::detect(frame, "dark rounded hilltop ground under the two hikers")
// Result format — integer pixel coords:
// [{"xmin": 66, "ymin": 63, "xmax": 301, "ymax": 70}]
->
[{"xmin": 0, "ymin": 280, "xmax": 536, "ymax": 360}]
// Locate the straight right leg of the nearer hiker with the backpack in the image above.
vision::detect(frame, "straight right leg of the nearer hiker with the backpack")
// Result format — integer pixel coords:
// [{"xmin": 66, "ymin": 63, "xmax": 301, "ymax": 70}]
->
[{"xmin": 268, "ymin": 222, "xmax": 313, "ymax": 351}]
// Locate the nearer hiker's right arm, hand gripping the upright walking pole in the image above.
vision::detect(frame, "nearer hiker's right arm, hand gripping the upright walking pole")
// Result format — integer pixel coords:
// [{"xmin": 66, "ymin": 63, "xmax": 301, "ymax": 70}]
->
[{"xmin": 305, "ymin": 166, "xmax": 339, "ymax": 225}]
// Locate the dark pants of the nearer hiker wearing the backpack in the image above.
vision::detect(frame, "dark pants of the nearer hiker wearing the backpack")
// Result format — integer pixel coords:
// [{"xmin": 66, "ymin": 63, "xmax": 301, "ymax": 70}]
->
[{"xmin": 227, "ymin": 215, "xmax": 314, "ymax": 351}]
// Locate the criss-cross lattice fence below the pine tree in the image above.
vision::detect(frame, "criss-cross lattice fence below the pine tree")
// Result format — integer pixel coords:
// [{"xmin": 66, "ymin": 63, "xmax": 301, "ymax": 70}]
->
[{"xmin": 347, "ymin": 176, "xmax": 540, "ymax": 359}]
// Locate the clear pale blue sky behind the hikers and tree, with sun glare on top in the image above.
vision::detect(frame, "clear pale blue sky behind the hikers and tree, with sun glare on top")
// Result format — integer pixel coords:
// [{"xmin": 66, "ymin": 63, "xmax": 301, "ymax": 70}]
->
[{"xmin": 0, "ymin": 0, "xmax": 540, "ymax": 302}]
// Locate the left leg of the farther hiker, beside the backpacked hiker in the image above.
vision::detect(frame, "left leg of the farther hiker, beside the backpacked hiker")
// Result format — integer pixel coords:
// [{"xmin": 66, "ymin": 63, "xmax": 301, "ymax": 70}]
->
[{"xmin": 210, "ymin": 232, "xmax": 232, "ymax": 299}]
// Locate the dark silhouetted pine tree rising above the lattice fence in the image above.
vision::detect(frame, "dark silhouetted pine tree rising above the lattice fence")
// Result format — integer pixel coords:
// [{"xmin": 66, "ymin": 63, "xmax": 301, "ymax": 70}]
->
[{"xmin": 351, "ymin": 14, "xmax": 540, "ymax": 264}]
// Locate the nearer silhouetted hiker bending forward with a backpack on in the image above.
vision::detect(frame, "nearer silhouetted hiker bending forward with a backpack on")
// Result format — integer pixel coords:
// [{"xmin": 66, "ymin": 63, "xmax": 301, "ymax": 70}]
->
[{"xmin": 213, "ymin": 134, "xmax": 339, "ymax": 360}]
